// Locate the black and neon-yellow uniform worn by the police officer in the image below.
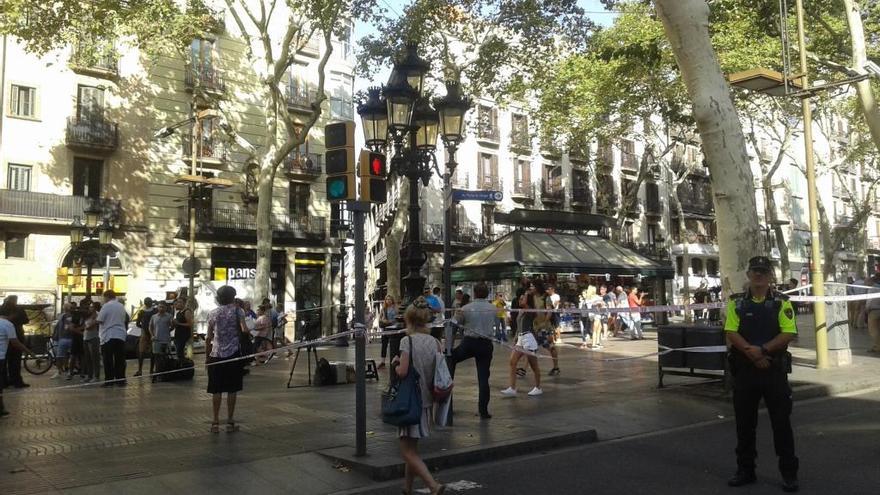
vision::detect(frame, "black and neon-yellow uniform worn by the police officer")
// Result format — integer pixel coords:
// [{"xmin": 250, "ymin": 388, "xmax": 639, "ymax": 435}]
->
[{"xmin": 724, "ymin": 274, "xmax": 798, "ymax": 491}]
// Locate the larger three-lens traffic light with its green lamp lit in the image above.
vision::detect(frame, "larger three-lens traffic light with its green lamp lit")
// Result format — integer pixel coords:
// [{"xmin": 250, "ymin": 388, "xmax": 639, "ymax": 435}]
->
[{"xmin": 324, "ymin": 120, "xmax": 357, "ymax": 202}]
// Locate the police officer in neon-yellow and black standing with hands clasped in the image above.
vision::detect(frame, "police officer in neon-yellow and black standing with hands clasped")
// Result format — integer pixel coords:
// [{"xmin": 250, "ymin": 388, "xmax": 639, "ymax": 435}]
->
[{"xmin": 724, "ymin": 256, "xmax": 799, "ymax": 492}]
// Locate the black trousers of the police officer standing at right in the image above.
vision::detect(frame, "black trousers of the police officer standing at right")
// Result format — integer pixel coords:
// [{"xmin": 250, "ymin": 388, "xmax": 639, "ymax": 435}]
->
[{"xmin": 733, "ymin": 365, "xmax": 798, "ymax": 476}]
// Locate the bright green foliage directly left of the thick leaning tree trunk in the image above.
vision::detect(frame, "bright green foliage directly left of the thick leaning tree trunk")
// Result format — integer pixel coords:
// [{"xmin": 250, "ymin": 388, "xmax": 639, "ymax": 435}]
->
[{"xmin": 521, "ymin": 2, "xmax": 690, "ymax": 143}]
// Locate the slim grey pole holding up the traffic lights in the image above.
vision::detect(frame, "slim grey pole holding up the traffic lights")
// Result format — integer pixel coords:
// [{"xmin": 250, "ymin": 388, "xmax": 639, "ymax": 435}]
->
[{"xmin": 348, "ymin": 201, "xmax": 370, "ymax": 457}]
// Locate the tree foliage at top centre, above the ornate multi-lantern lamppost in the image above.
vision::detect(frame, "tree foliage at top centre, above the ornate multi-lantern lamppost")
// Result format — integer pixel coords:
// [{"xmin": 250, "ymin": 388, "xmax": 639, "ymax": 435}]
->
[{"xmin": 358, "ymin": 0, "xmax": 591, "ymax": 100}]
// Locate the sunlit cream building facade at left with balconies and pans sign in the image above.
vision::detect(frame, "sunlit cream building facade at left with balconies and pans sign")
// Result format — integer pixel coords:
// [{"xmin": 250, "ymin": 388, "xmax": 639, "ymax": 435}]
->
[{"xmin": 0, "ymin": 7, "xmax": 354, "ymax": 336}]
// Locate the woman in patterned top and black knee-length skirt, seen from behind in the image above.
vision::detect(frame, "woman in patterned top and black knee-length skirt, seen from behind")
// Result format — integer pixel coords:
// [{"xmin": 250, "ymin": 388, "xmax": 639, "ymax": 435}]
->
[{"xmin": 205, "ymin": 285, "xmax": 248, "ymax": 433}]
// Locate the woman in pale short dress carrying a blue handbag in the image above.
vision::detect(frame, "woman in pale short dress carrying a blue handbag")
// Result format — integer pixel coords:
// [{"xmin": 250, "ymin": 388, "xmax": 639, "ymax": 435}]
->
[{"xmin": 392, "ymin": 297, "xmax": 446, "ymax": 495}]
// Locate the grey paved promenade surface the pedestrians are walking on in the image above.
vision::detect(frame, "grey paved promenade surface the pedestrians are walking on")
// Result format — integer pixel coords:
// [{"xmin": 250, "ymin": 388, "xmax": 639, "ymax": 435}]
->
[{"xmin": 0, "ymin": 322, "xmax": 880, "ymax": 495}]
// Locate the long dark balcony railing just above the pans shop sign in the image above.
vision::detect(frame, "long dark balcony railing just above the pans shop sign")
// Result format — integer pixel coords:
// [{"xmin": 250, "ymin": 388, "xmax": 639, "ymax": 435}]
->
[{"xmin": 178, "ymin": 206, "xmax": 327, "ymax": 242}]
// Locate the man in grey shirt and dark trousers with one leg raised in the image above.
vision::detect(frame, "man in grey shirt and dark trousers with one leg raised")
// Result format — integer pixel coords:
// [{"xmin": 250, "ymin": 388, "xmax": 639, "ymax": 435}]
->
[{"xmin": 450, "ymin": 283, "xmax": 498, "ymax": 419}]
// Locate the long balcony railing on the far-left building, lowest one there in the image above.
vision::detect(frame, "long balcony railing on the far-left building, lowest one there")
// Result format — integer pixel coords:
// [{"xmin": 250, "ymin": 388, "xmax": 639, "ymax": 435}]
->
[{"xmin": 0, "ymin": 189, "xmax": 122, "ymax": 224}]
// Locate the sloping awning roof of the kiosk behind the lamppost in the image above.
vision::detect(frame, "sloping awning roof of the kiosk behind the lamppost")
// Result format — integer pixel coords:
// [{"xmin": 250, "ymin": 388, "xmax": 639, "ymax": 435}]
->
[{"xmin": 452, "ymin": 230, "xmax": 675, "ymax": 282}]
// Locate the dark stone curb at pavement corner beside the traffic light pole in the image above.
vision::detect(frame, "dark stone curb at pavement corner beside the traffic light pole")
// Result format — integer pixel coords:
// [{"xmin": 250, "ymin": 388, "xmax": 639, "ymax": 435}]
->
[{"xmin": 317, "ymin": 429, "xmax": 598, "ymax": 481}]
